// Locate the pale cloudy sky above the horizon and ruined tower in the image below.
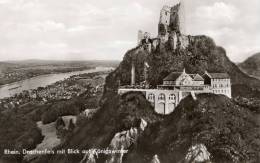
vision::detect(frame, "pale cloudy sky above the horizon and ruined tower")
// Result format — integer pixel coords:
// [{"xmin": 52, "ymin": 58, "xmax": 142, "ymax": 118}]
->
[{"xmin": 0, "ymin": 0, "xmax": 260, "ymax": 62}]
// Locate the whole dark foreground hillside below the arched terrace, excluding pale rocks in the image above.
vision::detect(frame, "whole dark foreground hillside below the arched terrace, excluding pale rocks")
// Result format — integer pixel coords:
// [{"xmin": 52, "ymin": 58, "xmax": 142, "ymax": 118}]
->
[{"xmin": 35, "ymin": 92, "xmax": 260, "ymax": 163}]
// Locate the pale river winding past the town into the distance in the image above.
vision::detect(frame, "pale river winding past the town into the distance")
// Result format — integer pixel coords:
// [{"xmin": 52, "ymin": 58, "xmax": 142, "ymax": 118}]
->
[{"xmin": 0, "ymin": 67, "xmax": 113, "ymax": 99}]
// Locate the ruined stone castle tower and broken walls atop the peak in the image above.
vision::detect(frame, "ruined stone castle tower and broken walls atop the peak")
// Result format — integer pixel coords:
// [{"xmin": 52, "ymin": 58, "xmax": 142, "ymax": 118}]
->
[{"xmin": 137, "ymin": 3, "xmax": 189, "ymax": 52}]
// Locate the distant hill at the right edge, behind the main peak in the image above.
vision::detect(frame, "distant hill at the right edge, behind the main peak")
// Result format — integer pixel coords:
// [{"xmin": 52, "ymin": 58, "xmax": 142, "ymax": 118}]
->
[{"xmin": 238, "ymin": 53, "xmax": 260, "ymax": 79}]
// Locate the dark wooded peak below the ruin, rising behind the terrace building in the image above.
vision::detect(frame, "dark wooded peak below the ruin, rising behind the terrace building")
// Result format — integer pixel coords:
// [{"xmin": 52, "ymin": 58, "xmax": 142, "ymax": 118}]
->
[{"xmin": 106, "ymin": 36, "xmax": 260, "ymax": 97}]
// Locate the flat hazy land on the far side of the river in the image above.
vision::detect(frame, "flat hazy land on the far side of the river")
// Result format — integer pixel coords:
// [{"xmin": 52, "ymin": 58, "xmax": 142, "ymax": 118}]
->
[{"xmin": 0, "ymin": 60, "xmax": 119, "ymax": 86}]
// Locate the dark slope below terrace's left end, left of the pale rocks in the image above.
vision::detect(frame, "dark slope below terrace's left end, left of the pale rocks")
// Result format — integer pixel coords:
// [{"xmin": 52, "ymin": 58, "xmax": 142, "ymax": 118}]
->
[{"xmin": 31, "ymin": 93, "xmax": 163, "ymax": 163}]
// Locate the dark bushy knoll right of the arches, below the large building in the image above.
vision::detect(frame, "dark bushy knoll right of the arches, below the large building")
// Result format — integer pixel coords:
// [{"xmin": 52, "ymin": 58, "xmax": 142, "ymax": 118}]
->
[{"xmin": 124, "ymin": 94, "xmax": 260, "ymax": 163}]
